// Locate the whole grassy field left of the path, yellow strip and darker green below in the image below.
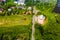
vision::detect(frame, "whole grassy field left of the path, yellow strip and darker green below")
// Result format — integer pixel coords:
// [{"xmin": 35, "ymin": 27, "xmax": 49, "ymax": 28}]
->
[{"xmin": 0, "ymin": 15, "xmax": 32, "ymax": 40}]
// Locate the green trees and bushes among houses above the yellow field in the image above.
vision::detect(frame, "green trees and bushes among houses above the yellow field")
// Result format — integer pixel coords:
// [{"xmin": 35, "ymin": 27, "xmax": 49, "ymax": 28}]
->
[{"xmin": 0, "ymin": 0, "xmax": 26, "ymax": 16}]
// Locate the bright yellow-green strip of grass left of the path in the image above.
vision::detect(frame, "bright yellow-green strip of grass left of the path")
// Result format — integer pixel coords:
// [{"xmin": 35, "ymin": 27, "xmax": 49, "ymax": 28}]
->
[{"xmin": 0, "ymin": 15, "xmax": 32, "ymax": 27}]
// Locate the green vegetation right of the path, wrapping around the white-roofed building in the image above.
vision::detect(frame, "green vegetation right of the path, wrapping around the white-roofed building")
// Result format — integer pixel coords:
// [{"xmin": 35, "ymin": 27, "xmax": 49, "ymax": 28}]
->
[{"xmin": 35, "ymin": 0, "xmax": 60, "ymax": 40}]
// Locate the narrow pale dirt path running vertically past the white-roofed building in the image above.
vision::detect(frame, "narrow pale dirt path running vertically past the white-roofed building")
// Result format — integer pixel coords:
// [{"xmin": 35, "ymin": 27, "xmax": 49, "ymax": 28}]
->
[{"xmin": 31, "ymin": 6, "xmax": 39, "ymax": 40}]
